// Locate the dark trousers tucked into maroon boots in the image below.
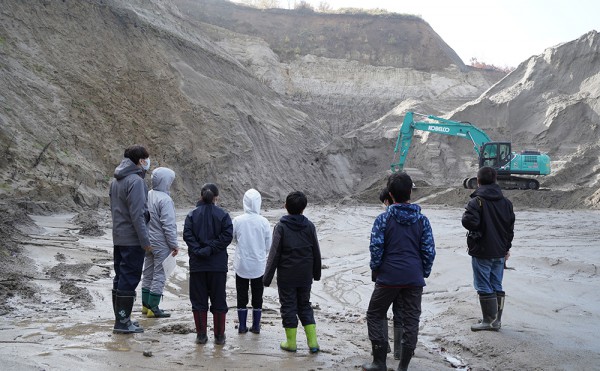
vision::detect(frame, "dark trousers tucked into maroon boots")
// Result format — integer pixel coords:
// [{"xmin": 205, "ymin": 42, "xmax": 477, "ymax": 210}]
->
[{"xmin": 190, "ymin": 272, "xmax": 228, "ymax": 313}]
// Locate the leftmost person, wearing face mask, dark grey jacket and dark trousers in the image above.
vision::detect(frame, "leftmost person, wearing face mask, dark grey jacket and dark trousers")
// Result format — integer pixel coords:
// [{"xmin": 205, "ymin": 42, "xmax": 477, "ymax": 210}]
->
[{"xmin": 109, "ymin": 145, "xmax": 152, "ymax": 334}]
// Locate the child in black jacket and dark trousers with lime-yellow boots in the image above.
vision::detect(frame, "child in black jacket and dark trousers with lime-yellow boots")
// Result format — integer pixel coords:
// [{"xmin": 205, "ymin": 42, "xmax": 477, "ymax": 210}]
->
[{"xmin": 263, "ymin": 191, "xmax": 321, "ymax": 353}]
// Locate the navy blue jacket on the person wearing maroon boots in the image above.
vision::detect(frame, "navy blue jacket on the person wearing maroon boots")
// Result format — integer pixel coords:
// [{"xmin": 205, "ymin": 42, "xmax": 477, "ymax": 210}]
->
[{"xmin": 183, "ymin": 201, "xmax": 233, "ymax": 273}]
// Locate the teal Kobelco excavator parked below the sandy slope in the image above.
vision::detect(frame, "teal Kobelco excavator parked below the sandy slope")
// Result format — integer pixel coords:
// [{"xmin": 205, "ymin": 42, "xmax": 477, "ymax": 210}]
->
[{"xmin": 391, "ymin": 112, "xmax": 550, "ymax": 189}]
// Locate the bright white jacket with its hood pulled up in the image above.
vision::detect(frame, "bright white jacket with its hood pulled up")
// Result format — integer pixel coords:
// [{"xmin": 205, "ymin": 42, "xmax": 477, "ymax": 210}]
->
[{"xmin": 233, "ymin": 189, "xmax": 272, "ymax": 279}]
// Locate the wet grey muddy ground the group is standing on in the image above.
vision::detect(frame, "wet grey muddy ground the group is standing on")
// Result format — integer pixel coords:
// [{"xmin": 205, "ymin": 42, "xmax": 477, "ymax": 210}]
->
[{"xmin": 0, "ymin": 193, "xmax": 600, "ymax": 370}]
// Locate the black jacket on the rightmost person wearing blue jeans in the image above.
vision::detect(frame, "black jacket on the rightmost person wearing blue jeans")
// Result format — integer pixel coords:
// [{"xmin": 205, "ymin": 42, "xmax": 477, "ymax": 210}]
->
[{"xmin": 462, "ymin": 184, "xmax": 515, "ymax": 259}]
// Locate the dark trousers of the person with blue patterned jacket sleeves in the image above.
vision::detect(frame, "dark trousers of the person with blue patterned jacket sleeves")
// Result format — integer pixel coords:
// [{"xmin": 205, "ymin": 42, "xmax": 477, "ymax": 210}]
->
[{"xmin": 367, "ymin": 284, "xmax": 423, "ymax": 349}]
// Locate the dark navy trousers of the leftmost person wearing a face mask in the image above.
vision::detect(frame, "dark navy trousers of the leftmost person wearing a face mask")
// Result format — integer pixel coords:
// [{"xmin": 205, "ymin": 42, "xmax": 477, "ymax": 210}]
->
[{"xmin": 113, "ymin": 246, "xmax": 146, "ymax": 291}]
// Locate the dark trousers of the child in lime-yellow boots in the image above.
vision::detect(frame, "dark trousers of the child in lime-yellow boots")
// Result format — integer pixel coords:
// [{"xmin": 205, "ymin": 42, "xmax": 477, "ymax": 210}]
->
[{"xmin": 277, "ymin": 286, "xmax": 315, "ymax": 328}]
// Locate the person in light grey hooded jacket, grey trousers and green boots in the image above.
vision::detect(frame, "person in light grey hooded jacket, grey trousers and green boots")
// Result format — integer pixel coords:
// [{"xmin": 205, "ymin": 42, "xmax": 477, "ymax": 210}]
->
[{"xmin": 142, "ymin": 167, "xmax": 179, "ymax": 318}]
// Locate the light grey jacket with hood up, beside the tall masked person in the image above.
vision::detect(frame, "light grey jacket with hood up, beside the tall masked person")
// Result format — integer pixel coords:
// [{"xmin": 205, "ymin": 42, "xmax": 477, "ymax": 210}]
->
[{"xmin": 148, "ymin": 167, "xmax": 178, "ymax": 250}]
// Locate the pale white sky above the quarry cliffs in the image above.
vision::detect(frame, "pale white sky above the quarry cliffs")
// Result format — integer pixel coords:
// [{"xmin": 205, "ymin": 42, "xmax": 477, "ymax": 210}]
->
[{"xmin": 264, "ymin": 0, "xmax": 600, "ymax": 67}]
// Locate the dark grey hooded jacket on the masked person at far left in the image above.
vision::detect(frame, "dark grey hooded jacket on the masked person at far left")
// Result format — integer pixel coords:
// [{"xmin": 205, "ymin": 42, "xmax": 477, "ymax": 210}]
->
[{"xmin": 109, "ymin": 158, "xmax": 150, "ymax": 247}]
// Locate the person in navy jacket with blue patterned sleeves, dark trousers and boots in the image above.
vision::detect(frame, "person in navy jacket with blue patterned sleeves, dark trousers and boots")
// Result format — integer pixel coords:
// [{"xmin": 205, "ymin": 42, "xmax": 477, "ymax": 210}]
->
[{"xmin": 363, "ymin": 172, "xmax": 435, "ymax": 371}]
